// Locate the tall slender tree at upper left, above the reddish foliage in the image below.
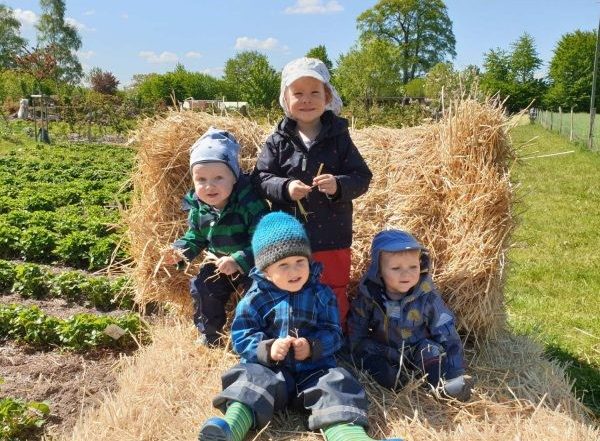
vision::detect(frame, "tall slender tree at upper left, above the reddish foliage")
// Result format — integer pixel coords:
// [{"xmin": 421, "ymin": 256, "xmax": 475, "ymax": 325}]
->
[{"xmin": 37, "ymin": 0, "xmax": 83, "ymax": 83}]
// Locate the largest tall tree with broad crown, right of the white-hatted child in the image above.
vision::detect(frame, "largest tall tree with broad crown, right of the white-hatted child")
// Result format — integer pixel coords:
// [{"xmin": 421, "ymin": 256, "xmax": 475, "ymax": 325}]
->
[{"xmin": 357, "ymin": 0, "xmax": 456, "ymax": 84}]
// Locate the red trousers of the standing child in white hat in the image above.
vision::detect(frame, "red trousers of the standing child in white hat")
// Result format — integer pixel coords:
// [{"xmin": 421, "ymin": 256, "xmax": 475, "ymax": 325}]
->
[{"xmin": 312, "ymin": 248, "xmax": 351, "ymax": 334}]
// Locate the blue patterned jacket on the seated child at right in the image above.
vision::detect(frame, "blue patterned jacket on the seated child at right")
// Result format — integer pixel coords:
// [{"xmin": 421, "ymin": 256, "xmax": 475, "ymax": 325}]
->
[{"xmin": 348, "ymin": 229, "xmax": 464, "ymax": 378}]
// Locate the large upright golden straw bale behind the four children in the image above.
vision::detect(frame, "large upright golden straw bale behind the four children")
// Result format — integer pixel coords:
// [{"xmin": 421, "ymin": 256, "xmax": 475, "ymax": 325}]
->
[{"xmin": 125, "ymin": 101, "xmax": 513, "ymax": 336}]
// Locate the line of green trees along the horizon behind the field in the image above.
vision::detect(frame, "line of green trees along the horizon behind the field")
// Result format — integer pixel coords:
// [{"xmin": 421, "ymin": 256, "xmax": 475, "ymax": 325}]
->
[{"xmin": 0, "ymin": 0, "xmax": 596, "ymax": 122}]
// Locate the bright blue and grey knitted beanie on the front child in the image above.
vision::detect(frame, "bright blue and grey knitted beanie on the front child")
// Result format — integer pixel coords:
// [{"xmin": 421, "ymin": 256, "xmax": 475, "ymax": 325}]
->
[{"xmin": 252, "ymin": 211, "xmax": 311, "ymax": 271}]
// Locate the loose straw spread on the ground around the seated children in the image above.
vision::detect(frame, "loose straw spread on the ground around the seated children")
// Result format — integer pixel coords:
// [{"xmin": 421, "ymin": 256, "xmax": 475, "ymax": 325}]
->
[{"xmin": 61, "ymin": 321, "xmax": 600, "ymax": 441}]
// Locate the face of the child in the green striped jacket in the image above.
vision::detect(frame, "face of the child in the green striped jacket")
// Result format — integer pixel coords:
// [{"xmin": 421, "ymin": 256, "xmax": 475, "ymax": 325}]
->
[{"xmin": 192, "ymin": 162, "xmax": 236, "ymax": 210}]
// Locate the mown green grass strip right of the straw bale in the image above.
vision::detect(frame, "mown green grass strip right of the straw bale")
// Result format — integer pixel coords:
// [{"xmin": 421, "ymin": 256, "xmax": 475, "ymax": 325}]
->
[{"xmin": 506, "ymin": 125, "xmax": 600, "ymax": 415}]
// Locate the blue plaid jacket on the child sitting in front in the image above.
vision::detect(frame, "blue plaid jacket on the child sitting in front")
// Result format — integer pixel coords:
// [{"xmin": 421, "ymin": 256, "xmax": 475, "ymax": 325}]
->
[{"xmin": 231, "ymin": 262, "xmax": 342, "ymax": 372}]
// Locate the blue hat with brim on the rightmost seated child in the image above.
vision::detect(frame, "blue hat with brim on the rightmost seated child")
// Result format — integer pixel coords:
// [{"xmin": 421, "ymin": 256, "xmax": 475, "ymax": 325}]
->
[{"xmin": 361, "ymin": 230, "xmax": 429, "ymax": 286}]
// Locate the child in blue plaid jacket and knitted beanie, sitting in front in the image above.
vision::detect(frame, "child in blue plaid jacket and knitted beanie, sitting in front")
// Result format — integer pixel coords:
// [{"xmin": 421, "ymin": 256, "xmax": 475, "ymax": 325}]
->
[{"xmin": 199, "ymin": 212, "xmax": 400, "ymax": 441}]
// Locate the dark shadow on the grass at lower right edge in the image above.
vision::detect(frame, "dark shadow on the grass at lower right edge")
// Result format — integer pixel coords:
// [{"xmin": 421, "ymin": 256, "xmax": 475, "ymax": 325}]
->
[{"xmin": 545, "ymin": 345, "xmax": 600, "ymax": 418}]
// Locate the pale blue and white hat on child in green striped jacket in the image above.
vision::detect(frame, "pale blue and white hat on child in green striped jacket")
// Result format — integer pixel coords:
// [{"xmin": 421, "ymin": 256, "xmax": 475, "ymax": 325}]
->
[{"xmin": 190, "ymin": 127, "xmax": 240, "ymax": 179}]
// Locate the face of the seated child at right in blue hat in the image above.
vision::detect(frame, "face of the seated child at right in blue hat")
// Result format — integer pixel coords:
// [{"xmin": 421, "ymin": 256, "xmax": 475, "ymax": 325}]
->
[{"xmin": 379, "ymin": 250, "xmax": 421, "ymax": 300}]
